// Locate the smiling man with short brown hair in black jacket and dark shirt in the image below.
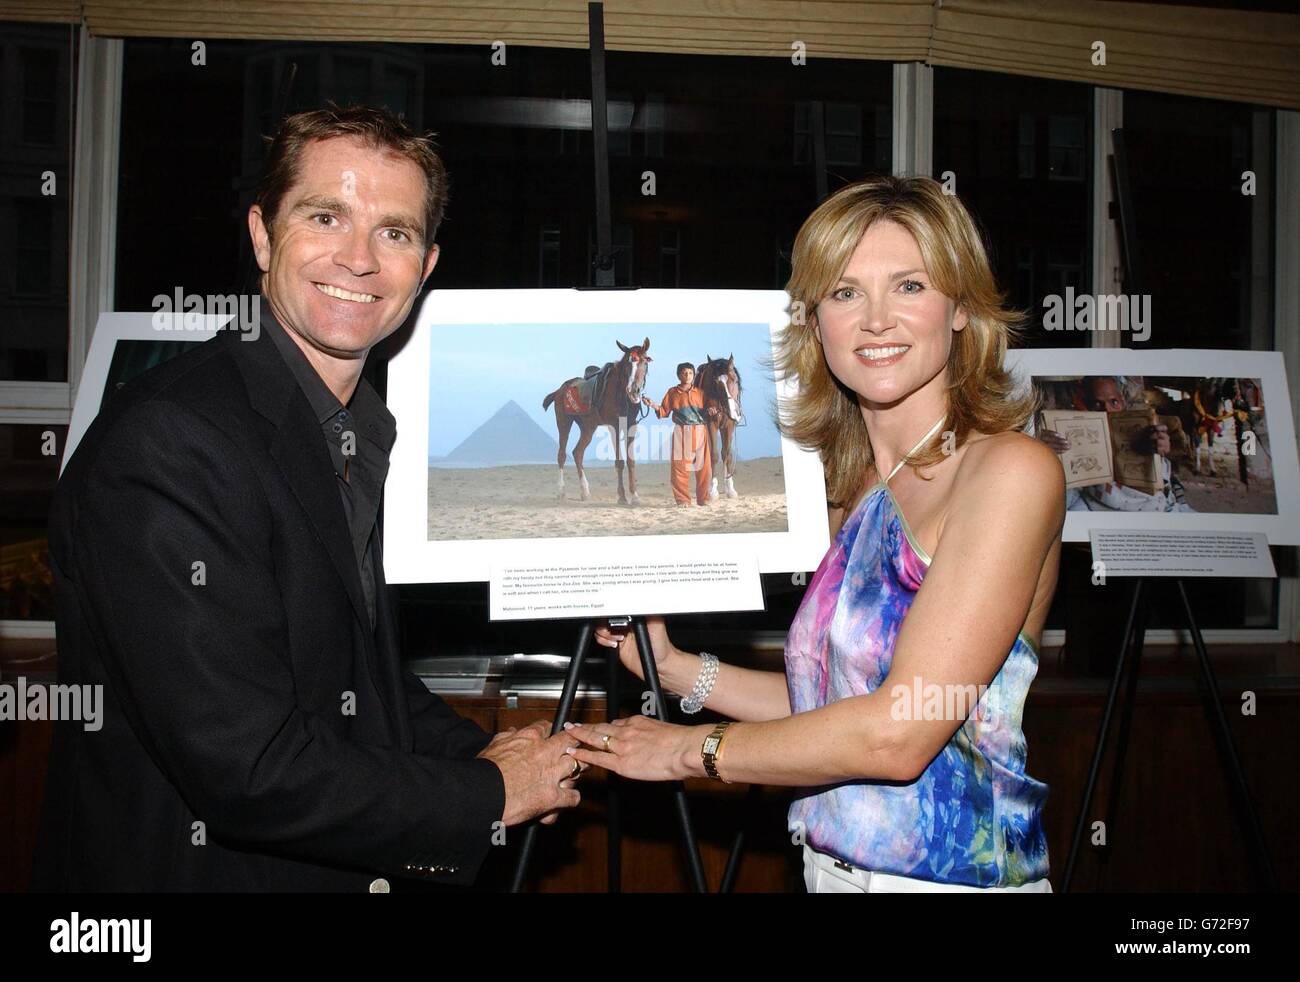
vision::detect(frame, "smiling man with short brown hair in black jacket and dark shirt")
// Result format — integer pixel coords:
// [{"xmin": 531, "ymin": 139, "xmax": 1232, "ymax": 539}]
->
[{"xmin": 33, "ymin": 108, "xmax": 579, "ymax": 892}]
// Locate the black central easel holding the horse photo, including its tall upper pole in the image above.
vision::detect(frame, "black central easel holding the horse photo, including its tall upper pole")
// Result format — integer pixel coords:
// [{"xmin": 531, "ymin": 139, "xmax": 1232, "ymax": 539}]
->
[{"xmin": 511, "ymin": 3, "xmax": 712, "ymax": 894}]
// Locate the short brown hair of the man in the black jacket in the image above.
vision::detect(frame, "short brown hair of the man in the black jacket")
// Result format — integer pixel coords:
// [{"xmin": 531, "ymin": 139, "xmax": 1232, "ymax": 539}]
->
[{"xmin": 255, "ymin": 103, "xmax": 447, "ymax": 250}]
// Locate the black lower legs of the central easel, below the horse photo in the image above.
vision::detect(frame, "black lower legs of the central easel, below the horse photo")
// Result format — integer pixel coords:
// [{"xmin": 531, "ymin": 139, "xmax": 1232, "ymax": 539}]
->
[{"xmin": 511, "ymin": 617, "xmax": 712, "ymax": 894}]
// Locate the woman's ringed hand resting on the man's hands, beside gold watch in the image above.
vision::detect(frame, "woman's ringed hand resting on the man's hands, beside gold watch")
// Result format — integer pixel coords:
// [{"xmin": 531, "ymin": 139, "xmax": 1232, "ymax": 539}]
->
[{"xmin": 564, "ymin": 717, "xmax": 714, "ymax": 780}]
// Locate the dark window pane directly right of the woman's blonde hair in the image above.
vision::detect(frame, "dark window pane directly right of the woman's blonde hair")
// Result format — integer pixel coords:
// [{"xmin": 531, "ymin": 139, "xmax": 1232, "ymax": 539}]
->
[{"xmin": 933, "ymin": 68, "xmax": 1092, "ymax": 347}]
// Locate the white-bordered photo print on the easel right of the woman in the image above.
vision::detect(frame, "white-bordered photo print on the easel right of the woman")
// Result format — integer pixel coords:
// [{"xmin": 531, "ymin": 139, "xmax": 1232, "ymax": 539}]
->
[{"xmin": 1008, "ymin": 349, "xmax": 1300, "ymax": 545}]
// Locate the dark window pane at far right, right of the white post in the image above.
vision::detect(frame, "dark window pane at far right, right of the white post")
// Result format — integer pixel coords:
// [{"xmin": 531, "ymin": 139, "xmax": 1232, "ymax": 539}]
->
[{"xmin": 1123, "ymin": 91, "xmax": 1274, "ymax": 350}]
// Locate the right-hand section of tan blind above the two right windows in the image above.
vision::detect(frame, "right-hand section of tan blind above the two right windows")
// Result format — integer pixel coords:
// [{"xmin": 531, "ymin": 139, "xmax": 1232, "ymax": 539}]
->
[{"xmin": 930, "ymin": 0, "xmax": 1300, "ymax": 109}]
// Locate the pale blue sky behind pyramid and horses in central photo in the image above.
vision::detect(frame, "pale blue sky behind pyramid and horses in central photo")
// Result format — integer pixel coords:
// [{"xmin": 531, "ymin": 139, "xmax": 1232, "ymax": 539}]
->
[{"xmin": 429, "ymin": 323, "xmax": 781, "ymax": 459}]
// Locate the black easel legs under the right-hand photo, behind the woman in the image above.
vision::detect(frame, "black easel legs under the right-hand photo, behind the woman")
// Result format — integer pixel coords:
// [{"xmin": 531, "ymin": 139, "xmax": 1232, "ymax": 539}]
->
[{"xmin": 1061, "ymin": 577, "xmax": 1277, "ymax": 894}]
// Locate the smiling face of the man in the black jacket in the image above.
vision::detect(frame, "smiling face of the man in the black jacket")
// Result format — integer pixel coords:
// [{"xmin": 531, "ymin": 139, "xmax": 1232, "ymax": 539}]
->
[{"xmin": 248, "ymin": 137, "xmax": 438, "ymax": 360}]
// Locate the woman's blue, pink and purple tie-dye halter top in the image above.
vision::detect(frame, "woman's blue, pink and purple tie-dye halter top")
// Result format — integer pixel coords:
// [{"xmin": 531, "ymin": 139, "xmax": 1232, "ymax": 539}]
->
[{"xmin": 785, "ymin": 483, "xmax": 1048, "ymax": 887}]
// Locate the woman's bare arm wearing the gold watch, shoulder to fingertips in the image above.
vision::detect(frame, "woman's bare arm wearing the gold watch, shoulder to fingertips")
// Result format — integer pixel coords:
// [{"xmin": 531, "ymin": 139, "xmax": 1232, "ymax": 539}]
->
[{"xmin": 573, "ymin": 434, "xmax": 1065, "ymax": 787}]
